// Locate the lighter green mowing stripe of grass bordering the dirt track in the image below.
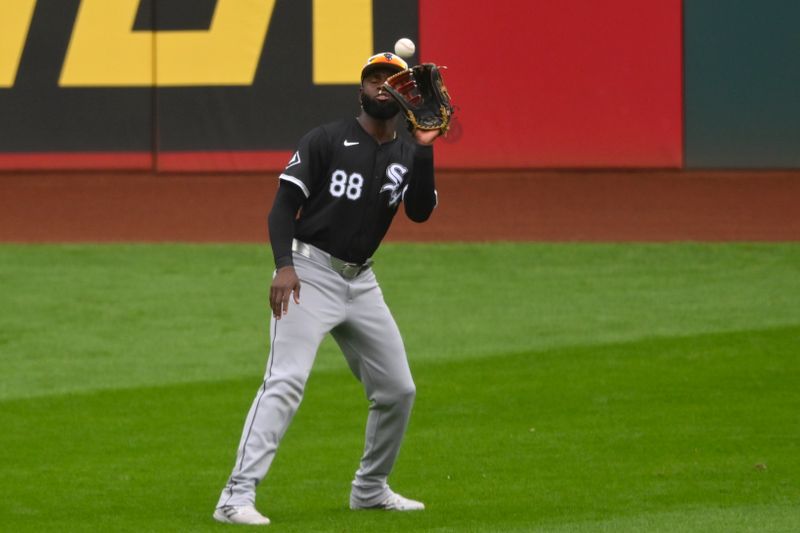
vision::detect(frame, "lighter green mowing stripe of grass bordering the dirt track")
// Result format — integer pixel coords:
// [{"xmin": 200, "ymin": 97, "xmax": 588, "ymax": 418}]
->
[{"xmin": 0, "ymin": 243, "xmax": 800, "ymax": 401}]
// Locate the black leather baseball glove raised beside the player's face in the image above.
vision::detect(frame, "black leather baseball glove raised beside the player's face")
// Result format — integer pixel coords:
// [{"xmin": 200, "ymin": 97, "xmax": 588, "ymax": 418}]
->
[{"xmin": 383, "ymin": 63, "xmax": 453, "ymax": 133}]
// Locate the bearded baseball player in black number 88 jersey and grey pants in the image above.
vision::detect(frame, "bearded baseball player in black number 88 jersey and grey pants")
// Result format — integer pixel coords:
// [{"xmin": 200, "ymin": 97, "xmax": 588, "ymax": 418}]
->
[{"xmin": 214, "ymin": 53, "xmax": 440, "ymax": 524}]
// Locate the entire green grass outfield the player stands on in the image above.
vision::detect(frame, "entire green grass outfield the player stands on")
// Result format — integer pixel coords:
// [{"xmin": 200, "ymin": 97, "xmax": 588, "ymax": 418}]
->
[{"xmin": 0, "ymin": 244, "xmax": 800, "ymax": 532}]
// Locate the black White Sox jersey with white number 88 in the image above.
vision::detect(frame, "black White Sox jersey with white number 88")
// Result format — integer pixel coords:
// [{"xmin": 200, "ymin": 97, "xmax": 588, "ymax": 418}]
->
[{"xmin": 280, "ymin": 118, "xmax": 436, "ymax": 263}]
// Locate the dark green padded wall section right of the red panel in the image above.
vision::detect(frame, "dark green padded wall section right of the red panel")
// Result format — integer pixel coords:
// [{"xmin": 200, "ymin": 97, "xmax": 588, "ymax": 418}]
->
[{"xmin": 684, "ymin": 0, "xmax": 800, "ymax": 168}]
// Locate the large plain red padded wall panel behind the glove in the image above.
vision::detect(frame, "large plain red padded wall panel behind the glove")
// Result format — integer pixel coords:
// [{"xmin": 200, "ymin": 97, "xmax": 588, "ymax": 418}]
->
[{"xmin": 419, "ymin": 0, "xmax": 683, "ymax": 168}]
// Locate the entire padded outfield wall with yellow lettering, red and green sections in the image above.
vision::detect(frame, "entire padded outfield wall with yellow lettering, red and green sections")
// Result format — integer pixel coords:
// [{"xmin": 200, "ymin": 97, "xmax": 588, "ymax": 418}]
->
[{"xmin": 0, "ymin": 0, "xmax": 800, "ymax": 171}]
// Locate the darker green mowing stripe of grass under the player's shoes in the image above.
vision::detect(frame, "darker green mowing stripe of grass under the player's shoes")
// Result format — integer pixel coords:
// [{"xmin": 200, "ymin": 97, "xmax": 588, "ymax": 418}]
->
[{"xmin": 0, "ymin": 327, "xmax": 800, "ymax": 532}]
